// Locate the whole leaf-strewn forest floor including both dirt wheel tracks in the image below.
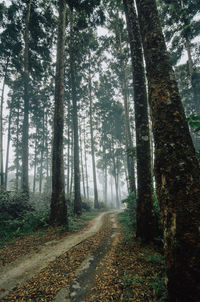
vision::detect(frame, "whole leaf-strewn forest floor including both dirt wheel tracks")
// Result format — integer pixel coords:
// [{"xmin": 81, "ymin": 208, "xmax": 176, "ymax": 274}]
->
[{"xmin": 0, "ymin": 212, "xmax": 165, "ymax": 302}]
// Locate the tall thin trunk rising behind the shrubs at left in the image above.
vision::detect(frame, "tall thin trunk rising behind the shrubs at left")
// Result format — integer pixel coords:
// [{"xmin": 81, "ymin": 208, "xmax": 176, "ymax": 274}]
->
[{"xmin": 21, "ymin": 0, "xmax": 32, "ymax": 198}]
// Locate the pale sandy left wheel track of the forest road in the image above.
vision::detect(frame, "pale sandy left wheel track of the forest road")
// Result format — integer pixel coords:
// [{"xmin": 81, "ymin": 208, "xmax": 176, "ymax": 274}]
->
[{"xmin": 0, "ymin": 213, "xmax": 117, "ymax": 301}]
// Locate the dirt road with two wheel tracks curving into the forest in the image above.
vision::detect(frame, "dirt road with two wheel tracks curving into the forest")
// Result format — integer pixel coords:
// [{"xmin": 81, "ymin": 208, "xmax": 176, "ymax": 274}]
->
[{"xmin": 0, "ymin": 212, "xmax": 117, "ymax": 302}]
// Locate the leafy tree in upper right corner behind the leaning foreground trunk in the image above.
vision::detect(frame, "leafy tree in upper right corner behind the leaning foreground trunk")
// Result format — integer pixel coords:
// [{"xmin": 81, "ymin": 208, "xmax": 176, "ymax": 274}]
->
[{"xmin": 158, "ymin": 0, "xmax": 200, "ymax": 114}]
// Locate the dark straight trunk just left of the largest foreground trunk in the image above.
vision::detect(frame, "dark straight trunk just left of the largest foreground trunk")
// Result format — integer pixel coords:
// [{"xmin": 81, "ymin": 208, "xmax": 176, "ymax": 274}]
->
[{"xmin": 124, "ymin": 0, "xmax": 155, "ymax": 242}]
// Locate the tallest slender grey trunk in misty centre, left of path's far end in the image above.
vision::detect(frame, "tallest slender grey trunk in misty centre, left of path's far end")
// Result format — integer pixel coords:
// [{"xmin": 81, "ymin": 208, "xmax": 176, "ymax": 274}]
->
[{"xmin": 88, "ymin": 55, "xmax": 99, "ymax": 209}]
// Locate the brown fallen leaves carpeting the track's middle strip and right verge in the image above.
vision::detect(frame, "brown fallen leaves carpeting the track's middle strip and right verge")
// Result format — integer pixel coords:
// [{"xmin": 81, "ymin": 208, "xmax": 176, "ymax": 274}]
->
[{"xmin": 1, "ymin": 215, "xmax": 164, "ymax": 302}]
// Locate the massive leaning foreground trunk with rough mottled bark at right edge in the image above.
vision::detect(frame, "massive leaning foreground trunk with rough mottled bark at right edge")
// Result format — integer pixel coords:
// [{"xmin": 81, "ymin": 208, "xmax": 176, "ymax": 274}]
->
[{"xmin": 136, "ymin": 0, "xmax": 200, "ymax": 302}]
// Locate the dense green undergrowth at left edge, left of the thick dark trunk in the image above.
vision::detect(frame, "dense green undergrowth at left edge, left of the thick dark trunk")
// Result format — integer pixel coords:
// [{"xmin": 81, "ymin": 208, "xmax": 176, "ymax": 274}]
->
[{"xmin": 0, "ymin": 191, "xmax": 49, "ymax": 245}]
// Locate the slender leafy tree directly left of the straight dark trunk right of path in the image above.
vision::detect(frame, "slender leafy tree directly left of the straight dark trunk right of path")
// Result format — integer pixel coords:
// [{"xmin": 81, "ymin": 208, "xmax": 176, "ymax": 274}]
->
[{"xmin": 101, "ymin": 1, "xmax": 136, "ymax": 193}]
